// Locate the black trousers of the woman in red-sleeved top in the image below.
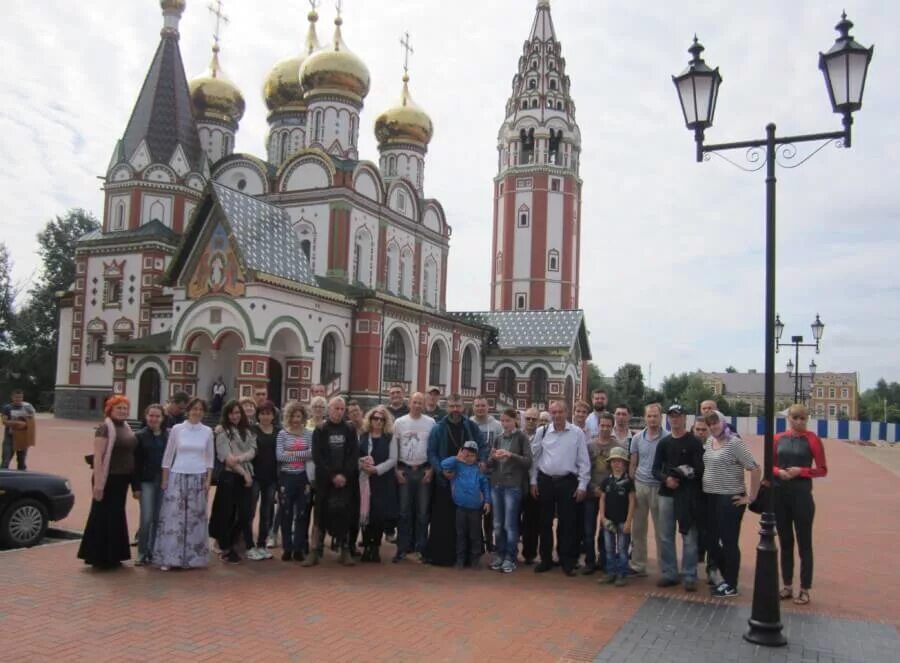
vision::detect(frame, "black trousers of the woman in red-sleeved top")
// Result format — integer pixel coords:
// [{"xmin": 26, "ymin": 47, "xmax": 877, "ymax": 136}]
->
[{"xmin": 775, "ymin": 478, "xmax": 816, "ymax": 589}]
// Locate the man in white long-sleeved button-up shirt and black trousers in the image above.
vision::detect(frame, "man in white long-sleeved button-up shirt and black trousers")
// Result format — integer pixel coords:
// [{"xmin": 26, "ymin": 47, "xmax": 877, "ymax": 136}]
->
[{"xmin": 531, "ymin": 401, "xmax": 591, "ymax": 576}]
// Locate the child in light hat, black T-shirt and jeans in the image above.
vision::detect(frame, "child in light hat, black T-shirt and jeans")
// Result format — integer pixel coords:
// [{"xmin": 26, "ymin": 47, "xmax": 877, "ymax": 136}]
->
[{"xmin": 599, "ymin": 447, "xmax": 634, "ymax": 587}]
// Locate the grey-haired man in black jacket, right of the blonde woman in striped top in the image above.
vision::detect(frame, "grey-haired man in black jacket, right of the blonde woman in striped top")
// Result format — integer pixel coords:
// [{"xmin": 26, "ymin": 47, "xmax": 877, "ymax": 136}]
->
[{"xmin": 308, "ymin": 397, "xmax": 359, "ymax": 566}]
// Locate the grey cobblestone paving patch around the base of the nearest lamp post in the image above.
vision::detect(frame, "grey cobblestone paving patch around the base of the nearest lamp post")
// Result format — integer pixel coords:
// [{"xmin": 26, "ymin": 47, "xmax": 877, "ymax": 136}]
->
[{"xmin": 596, "ymin": 597, "xmax": 900, "ymax": 663}]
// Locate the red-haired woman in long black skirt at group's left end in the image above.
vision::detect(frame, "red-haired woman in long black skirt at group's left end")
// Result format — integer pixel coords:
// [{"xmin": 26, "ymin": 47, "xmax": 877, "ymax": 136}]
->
[{"xmin": 78, "ymin": 396, "xmax": 137, "ymax": 569}]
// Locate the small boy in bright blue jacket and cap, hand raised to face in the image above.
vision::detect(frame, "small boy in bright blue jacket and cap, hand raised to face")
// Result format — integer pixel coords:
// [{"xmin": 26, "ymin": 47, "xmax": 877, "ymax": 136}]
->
[{"xmin": 441, "ymin": 440, "xmax": 491, "ymax": 569}]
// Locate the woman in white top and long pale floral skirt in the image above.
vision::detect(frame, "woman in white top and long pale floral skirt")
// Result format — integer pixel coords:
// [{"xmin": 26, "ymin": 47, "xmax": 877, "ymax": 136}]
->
[{"xmin": 153, "ymin": 398, "xmax": 215, "ymax": 571}]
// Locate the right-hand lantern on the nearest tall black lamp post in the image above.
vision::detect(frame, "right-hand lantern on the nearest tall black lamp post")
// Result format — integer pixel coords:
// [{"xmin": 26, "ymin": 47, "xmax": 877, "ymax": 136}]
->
[{"xmin": 819, "ymin": 13, "xmax": 875, "ymax": 117}]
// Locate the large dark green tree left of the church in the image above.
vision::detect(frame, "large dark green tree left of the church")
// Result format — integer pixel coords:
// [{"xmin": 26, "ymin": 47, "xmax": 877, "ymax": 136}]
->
[{"xmin": 13, "ymin": 209, "xmax": 100, "ymax": 404}]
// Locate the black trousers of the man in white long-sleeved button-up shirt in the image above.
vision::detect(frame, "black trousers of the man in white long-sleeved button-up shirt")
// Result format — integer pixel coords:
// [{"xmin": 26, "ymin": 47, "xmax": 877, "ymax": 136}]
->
[{"xmin": 538, "ymin": 472, "xmax": 578, "ymax": 571}]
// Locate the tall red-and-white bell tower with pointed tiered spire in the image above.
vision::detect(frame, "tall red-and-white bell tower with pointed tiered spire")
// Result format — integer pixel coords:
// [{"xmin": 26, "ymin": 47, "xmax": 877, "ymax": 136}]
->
[{"xmin": 491, "ymin": 0, "xmax": 582, "ymax": 311}]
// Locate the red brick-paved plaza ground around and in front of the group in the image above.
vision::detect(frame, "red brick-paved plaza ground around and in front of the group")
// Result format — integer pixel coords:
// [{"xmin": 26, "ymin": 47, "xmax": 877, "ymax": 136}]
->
[{"xmin": 0, "ymin": 419, "xmax": 900, "ymax": 662}]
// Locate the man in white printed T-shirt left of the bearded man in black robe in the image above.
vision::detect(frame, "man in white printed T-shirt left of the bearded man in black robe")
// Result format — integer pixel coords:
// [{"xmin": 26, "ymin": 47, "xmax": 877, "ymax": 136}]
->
[{"xmin": 393, "ymin": 392, "xmax": 434, "ymax": 562}]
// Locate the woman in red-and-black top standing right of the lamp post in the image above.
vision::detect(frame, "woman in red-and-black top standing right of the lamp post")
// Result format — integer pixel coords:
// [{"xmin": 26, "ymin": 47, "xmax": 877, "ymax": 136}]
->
[{"xmin": 772, "ymin": 404, "xmax": 828, "ymax": 605}]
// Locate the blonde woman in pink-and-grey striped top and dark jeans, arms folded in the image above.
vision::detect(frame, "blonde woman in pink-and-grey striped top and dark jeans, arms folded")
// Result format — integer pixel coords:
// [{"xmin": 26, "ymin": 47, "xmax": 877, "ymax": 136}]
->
[{"xmin": 275, "ymin": 401, "xmax": 312, "ymax": 562}]
